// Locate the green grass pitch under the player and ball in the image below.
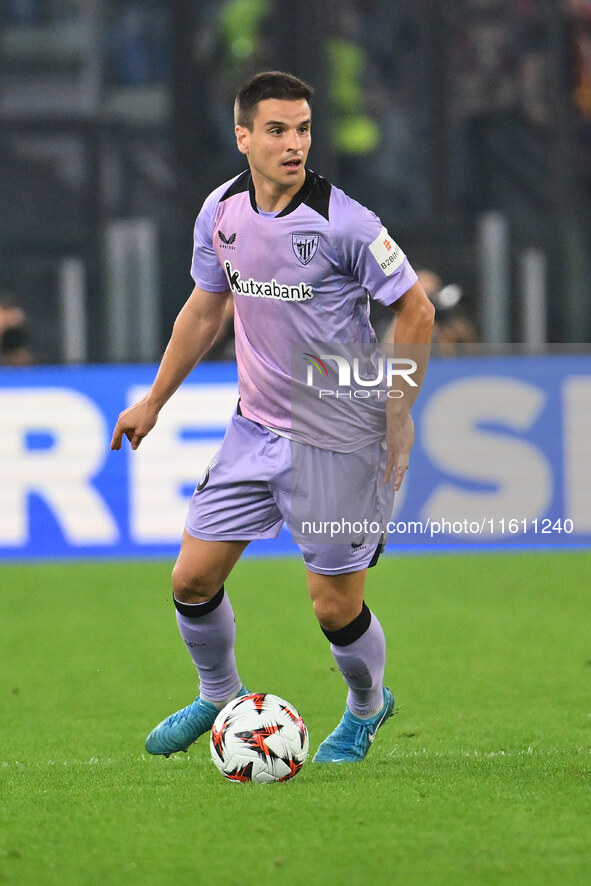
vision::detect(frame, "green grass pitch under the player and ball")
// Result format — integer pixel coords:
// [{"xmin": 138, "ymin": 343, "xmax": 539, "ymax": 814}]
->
[{"xmin": 0, "ymin": 551, "xmax": 591, "ymax": 886}]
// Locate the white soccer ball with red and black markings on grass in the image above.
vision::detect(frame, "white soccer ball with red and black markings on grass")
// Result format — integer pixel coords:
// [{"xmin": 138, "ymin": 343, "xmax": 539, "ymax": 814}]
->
[{"xmin": 209, "ymin": 692, "xmax": 308, "ymax": 782}]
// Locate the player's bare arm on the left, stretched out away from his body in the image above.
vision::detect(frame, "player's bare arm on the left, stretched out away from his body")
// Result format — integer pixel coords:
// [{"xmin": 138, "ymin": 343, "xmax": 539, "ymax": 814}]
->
[{"xmin": 111, "ymin": 286, "xmax": 229, "ymax": 449}]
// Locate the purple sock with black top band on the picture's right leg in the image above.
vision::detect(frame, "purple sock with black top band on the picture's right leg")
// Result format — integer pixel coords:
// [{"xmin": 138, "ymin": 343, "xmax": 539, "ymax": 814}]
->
[{"xmin": 324, "ymin": 604, "xmax": 386, "ymax": 717}]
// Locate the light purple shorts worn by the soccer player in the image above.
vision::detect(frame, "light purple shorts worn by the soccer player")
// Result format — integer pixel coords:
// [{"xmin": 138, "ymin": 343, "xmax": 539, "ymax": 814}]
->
[{"xmin": 185, "ymin": 414, "xmax": 394, "ymax": 575}]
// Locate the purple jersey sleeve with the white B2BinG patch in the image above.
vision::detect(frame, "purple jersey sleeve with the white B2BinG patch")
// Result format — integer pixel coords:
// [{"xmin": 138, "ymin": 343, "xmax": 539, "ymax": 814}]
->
[{"xmin": 331, "ymin": 189, "xmax": 418, "ymax": 305}]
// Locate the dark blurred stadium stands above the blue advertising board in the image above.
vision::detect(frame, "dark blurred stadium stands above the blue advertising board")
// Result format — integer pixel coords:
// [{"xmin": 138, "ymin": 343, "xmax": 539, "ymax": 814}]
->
[{"xmin": 0, "ymin": 0, "xmax": 591, "ymax": 363}]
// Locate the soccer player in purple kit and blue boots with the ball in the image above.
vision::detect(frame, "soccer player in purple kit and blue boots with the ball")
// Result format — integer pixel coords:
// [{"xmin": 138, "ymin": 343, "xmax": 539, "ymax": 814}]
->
[{"xmin": 111, "ymin": 71, "xmax": 433, "ymax": 763}]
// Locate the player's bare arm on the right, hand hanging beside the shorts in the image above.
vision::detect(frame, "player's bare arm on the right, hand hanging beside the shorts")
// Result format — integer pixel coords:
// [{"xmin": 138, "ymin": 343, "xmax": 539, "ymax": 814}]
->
[{"xmin": 384, "ymin": 282, "xmax": 435, "ymax": 490}]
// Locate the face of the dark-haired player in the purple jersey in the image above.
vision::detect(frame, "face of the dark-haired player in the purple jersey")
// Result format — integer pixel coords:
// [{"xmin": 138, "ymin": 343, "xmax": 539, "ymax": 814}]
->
[{"xmin": 236, "ymin": 98, "xmax": 311, "ymax": 192}]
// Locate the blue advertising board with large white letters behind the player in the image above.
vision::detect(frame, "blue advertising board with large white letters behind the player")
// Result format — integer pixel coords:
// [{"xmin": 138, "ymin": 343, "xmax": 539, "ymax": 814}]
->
[{"xmin": 0, "ymin": 355, "xmax": 591, "ymax": 559}]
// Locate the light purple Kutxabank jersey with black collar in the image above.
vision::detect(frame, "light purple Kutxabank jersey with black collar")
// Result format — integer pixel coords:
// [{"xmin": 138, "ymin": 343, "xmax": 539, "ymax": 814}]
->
[{"xmin": 191, "ymin": 170, "xmax": 417, "ymax": 451}]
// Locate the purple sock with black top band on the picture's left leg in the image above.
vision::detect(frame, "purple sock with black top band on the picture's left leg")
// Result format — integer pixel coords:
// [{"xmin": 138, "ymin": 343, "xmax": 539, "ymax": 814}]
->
[{"xmin": 174, "ymin": 587, "xmax": 242, "ymax": 705}]
